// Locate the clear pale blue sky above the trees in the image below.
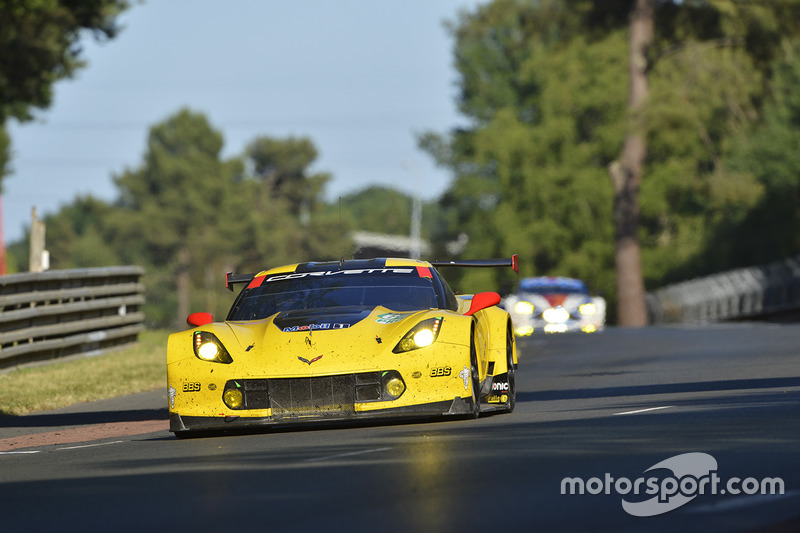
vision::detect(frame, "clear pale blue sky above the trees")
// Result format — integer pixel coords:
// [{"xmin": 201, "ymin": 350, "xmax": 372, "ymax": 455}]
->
[{"xmin": 3, "ymin": 0, "xmax": 484, "ymax": 243}]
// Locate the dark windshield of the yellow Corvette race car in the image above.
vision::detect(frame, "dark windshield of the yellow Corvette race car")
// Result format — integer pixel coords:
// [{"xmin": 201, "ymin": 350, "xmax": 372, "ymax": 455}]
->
[{"xmin": 228, "ymin": 274, "xmax": 440, "ymax": 320}]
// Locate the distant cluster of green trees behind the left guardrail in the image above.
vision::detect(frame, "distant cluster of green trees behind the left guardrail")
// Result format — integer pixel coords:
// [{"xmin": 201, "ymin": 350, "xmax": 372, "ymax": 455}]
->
[{"xmin": 30, "ymin": 109, "xmax": 351, "ymax": 327}]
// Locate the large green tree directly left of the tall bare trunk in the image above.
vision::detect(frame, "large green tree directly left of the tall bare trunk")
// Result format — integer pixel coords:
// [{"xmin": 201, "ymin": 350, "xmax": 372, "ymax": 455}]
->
[{"xmin": 420, "ymin": 0, "xmax": 625, "ymax": 300}]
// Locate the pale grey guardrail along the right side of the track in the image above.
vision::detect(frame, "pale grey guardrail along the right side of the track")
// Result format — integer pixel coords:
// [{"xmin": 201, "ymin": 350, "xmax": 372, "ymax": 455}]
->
[{"xmin": 647, "ymin": 255, "xmax": 800, "ymax": 324}]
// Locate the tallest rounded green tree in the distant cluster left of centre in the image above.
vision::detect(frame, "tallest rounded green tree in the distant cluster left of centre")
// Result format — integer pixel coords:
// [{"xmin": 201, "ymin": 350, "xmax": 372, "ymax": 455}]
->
[{"xmin": 114, "ymin": 109, "xmax": 241, "ymax": 324}]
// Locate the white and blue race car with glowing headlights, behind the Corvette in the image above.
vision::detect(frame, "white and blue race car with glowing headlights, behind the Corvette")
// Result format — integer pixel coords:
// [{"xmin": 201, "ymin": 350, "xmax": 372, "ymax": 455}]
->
[{"xmin": 501, "ymin": 277, "xmax": 606, "ymax": 336}]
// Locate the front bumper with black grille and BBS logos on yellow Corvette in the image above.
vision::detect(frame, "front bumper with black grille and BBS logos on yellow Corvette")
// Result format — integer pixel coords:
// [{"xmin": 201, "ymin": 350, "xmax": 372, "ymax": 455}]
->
[{"xmin": 168, "ymin": 367, "xmax": 482, "ymax": 433}]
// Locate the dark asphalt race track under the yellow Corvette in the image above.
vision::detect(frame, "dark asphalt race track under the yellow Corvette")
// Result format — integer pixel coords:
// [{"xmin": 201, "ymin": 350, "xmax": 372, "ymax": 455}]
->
[{"xmin": 0, "ymin": 324, "xmax": 800, "ymax": 532}]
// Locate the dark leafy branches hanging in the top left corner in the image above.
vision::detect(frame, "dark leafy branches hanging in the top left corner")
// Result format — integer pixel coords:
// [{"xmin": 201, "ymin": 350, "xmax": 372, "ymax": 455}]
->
[{"xmin": 0, "ymin": 0, "xmax": 128, "ymax": 186}]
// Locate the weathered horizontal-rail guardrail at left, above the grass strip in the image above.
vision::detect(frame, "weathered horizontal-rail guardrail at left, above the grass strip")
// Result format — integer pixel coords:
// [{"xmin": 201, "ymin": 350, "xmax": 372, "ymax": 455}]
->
[{"xmin": 0, "ymin": 266, "xmax": 145, "ymax": 369}]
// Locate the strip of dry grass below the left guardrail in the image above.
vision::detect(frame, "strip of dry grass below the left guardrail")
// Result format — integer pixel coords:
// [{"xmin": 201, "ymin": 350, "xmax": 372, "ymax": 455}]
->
[{"xmin": 0, "ymin": 331, "xmax": 169, "ymax": 415}]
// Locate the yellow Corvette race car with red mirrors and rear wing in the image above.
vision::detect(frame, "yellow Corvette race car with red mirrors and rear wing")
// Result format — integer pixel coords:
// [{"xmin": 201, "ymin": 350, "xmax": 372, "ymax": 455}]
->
[{"xmin": 167, "ymin": 256, "xmax": 517, "ymax": 436}]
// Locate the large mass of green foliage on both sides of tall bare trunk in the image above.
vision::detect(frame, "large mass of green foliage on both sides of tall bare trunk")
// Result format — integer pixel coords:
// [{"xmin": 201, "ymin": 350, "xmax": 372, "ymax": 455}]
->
[{"xmin": 419, "ymin": 0, "xmax": 800, "ymax": 320}]
